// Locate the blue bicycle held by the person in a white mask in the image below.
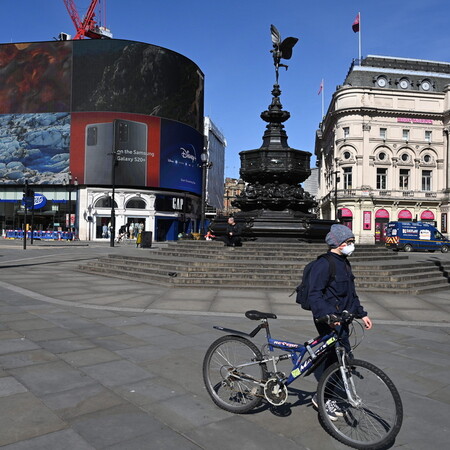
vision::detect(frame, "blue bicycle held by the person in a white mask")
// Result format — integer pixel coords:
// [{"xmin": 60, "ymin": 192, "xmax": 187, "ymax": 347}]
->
[{"xmin": 203, "ymin": 310, "xmax": 403, "ymax": 449}]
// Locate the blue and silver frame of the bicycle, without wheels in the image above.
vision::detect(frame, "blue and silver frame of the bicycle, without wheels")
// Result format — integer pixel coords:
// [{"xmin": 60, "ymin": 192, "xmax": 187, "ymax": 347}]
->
[{"xmin": 214, "ymin": 319, "xmax": 347, "ymax": 386}]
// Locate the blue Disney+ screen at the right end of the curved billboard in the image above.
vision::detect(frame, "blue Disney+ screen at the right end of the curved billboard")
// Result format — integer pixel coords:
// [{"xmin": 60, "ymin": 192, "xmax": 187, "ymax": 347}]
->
[{"xmin": 160, "ymin": 119, "xmax": 203, "ymax": 194}]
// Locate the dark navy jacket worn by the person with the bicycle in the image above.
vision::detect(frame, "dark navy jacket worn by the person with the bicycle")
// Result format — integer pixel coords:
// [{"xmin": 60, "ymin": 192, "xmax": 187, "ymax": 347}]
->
[{"xmin": 309, "ymin": 252, "xmax": 367, "ymax": 318}]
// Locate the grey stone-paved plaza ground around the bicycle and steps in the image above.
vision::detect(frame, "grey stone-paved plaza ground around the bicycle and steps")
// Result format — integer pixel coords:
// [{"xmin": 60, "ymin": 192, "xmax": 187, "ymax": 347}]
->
[{"xmin": 0, "ymin": 240, "xmax": 450, "ymax": 450}]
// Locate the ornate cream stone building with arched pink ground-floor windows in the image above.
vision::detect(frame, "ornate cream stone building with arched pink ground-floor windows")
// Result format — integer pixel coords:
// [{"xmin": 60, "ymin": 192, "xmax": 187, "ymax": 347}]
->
[{"xmin": 315, "ymin": 56, "xmax": 450, "ymax": 243}]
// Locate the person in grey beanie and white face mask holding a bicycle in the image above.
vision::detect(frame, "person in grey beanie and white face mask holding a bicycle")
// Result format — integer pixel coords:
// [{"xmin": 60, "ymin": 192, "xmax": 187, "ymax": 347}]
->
[{"xmin": 308, "ymin": 224, "xmax": 372, "ymax": 420}]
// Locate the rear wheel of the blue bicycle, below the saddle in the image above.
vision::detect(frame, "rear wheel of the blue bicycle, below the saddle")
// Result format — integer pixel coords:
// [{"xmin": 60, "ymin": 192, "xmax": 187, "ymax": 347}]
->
[{"xmin": 203, "ymin": 335, "xmax": 268, "ymax": 414}]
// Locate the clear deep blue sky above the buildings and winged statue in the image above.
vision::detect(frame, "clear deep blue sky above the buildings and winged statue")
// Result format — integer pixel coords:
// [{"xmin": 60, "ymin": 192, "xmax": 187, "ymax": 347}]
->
[{"xmin": 0, "ymin": 0, "xmax": 450, "ymax": 177}]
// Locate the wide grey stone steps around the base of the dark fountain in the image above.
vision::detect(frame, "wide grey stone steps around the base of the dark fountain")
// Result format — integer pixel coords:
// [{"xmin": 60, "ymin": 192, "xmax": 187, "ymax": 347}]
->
[{"xmin": 80, "ymin": 241, "xmax": 450, "ymax": 294}]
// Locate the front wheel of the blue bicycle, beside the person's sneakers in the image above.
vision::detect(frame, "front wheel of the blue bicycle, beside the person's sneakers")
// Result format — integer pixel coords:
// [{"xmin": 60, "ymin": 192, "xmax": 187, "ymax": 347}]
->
[{"xmin": 317, "ymin": 359, "xmax": 403, "ymax": 450}]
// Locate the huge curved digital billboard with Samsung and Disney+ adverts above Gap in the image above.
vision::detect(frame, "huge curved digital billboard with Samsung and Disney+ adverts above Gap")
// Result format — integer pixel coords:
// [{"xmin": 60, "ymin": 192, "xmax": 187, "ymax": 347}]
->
[{"xmin": 0, "ymin": 40, "xmax": 203, "ymax": 194}]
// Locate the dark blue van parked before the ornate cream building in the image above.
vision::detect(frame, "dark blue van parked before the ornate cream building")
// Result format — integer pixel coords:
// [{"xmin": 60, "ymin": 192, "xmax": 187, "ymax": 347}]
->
[{"xmin": 386, "ymin": 222, "xmax": 450, "ymax": 253}]
